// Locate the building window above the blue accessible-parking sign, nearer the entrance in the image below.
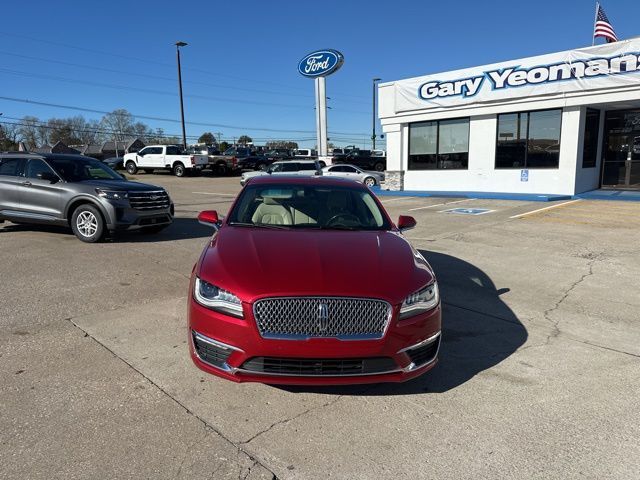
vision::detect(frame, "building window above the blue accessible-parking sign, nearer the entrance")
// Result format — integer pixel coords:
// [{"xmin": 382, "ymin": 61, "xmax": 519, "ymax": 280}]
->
[{"xmin": 496, "ymin": 110, "xmax": 562, "ymax": 168}]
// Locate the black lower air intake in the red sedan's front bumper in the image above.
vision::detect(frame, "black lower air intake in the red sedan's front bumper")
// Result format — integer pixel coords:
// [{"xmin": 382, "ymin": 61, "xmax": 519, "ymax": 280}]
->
[{"xmin": 240, "ymin": 357, "xmax": 398, "ymax": 377}]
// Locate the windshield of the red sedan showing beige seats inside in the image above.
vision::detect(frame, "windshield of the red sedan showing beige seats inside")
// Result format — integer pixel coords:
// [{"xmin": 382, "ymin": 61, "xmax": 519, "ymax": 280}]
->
[{"xmin": 229, "ymin": 185, "xmax": 391, "ymax": 230}]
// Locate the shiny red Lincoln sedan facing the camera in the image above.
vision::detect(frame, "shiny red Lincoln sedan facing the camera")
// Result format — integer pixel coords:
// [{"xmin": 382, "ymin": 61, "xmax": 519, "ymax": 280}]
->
[{"xmin": 188, "ymin": 177, "xmax": 441, "ymax": 385}]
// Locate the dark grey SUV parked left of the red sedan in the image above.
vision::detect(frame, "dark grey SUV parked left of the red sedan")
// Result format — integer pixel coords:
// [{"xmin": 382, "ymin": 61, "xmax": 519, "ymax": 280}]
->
[{"xmin": 0, "ymin": 152, "xmax": 174, "ymax": 243}]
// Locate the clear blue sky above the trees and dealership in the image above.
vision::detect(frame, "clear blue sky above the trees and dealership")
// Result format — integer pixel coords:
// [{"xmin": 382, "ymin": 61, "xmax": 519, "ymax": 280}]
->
[{"xmin": 0, "ymin": 0, "xmax": 640, "ymax": 146}]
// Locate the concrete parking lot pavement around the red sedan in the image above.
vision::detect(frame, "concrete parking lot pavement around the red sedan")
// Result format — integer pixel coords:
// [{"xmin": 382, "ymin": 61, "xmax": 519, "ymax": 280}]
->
[{"xmin": 0, "ymin": 174, "xmax": 640, "ymax": 479}]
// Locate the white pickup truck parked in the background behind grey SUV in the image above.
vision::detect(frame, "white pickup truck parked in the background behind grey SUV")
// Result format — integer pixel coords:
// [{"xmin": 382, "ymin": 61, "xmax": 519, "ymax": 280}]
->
[{"xmin": 124, "ymin": 145, "xmax": 209, "ymax": 177}]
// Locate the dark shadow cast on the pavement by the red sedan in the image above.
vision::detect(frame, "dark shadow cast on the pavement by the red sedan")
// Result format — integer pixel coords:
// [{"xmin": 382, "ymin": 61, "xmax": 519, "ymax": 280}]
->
[{"xmin": 278, "ymin": 250, "xmax": 528, "ymax": 396}]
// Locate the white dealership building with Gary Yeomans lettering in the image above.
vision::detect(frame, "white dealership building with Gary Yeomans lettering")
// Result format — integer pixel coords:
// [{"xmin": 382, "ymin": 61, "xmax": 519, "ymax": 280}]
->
[{"xmin": 378, "ymin": 38, "xmax": 640, "ymax": 195}]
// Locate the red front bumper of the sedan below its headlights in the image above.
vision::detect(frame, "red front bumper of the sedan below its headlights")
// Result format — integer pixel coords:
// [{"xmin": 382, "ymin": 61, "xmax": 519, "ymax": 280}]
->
[{"xmin": 188, "ymin": 298, "xmax": 441, "ymax": 385}]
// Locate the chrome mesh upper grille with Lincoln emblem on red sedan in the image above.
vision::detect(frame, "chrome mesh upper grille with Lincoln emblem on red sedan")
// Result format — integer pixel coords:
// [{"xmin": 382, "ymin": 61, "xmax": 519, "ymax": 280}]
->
[{"xmin": 253, "ymin": 297, "xmax": 391, "ymax": 340}]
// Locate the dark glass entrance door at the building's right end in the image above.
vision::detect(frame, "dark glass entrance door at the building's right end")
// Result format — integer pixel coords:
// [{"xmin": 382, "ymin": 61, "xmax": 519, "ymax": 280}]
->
[{"xmin": 602, "ymin": 110, "xmax": 640, "ymax": 190}]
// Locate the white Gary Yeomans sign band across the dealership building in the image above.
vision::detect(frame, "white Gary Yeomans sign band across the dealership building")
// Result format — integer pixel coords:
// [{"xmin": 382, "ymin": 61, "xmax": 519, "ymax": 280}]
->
[{"xmin": 394, "ymin": 40, "xmax": 640, "ymax": 112}]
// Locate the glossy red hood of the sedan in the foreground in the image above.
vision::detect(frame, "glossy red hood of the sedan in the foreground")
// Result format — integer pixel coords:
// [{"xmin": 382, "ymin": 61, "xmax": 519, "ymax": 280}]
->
[{"xmin": 196, "ymin": 226, "xmax": 434, "ymax": 304}]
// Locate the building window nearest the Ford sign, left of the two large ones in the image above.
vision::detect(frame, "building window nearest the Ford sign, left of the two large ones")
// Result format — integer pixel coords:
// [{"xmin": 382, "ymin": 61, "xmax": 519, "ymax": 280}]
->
[{"xmin": 409, "ymin": 118, "xmax": 469, "ymax": 170}]
